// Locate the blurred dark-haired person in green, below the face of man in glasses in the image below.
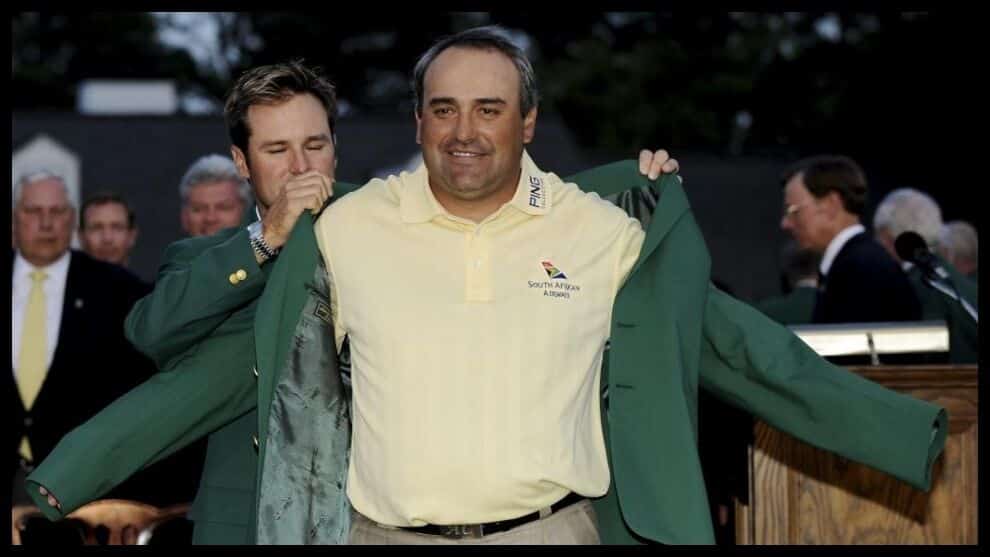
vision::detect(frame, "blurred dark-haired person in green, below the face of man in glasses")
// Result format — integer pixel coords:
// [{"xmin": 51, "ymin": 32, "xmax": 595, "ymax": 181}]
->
[{"xmin": 756, "ymin": 240, "xmax": 821, "ymax": 325}]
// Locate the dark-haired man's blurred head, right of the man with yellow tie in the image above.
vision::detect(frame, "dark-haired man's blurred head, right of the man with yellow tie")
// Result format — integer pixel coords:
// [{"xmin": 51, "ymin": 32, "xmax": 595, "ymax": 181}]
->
[{"xmin": 79, "ymin": 191, "xmax": 138, "ymax": 267}]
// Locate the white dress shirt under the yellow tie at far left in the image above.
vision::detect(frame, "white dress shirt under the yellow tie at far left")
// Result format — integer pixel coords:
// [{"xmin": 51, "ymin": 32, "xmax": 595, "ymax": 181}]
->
[{"xmin": 10, "ymin": 251, "xmax": 72, "ymax": 378}]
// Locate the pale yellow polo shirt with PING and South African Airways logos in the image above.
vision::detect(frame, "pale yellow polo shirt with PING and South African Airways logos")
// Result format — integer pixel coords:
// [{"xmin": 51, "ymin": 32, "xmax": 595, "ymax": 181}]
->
[{"xmin": 316, "ymin": 153, "xmax": 645, "ymax": 526}]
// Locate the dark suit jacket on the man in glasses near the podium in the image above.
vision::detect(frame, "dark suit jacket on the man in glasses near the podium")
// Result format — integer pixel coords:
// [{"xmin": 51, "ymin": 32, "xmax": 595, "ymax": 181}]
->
[{"xmin": 812, "ymin": 233, "xmax": 921, "ymax": 323}]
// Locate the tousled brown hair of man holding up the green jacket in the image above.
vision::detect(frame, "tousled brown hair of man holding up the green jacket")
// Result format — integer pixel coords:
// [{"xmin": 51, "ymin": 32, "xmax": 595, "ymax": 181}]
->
[{"xmin": 223, "ymin": 60, "xmax": 337, "ymax": 156}]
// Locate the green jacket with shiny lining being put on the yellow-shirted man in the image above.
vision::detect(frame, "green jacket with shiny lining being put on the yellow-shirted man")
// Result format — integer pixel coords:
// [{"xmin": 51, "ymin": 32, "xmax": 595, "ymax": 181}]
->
[{"xmin": 30, "ymin": 161, "xmax": 947, "ymax": 543}]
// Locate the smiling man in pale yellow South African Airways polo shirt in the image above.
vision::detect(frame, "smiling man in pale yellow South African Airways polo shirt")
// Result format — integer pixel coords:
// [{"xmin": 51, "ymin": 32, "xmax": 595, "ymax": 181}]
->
[{"xmin": 316, "ymin": 30, "xmax": 643, "ymax": 544}]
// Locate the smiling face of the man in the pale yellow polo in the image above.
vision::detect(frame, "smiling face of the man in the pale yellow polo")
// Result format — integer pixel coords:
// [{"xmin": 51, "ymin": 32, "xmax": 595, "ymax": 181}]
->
[{"xmin": 416, "ymin": 47, "xmax": 536, "ymax": 219}]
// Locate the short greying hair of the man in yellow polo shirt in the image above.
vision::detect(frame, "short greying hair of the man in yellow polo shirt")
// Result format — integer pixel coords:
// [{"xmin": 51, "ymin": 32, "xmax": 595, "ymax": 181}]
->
[{"xmin": 412, "ymin": 25, "xmax": 540, "ymax": 117}]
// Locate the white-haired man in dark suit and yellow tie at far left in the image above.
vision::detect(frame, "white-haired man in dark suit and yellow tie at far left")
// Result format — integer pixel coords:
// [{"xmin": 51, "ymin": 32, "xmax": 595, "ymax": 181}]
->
[{"xmin": 7, "ymin": 171, "xmax": 153, "ymax": 505}]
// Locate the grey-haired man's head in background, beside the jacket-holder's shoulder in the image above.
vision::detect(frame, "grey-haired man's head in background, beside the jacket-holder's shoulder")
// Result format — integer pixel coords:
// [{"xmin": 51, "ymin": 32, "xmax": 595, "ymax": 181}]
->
[{"xmin": 179, "ymin": 154, "xmax": 252, "ymax": 236}]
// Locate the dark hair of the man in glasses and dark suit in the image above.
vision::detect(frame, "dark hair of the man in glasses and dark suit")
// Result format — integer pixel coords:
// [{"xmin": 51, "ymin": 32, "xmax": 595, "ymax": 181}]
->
[{"xmin": 781, "ymin": 155, "xmax": 867, "ymax": 215}]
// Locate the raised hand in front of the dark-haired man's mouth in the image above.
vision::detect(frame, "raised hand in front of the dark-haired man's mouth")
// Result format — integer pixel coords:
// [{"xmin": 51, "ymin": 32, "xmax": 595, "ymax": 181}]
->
[{"xmin": 261, "ymin": 170, "xmax": 333, "ymax": 249}]
